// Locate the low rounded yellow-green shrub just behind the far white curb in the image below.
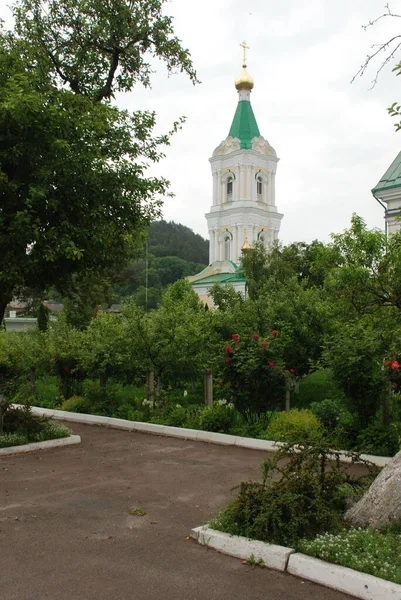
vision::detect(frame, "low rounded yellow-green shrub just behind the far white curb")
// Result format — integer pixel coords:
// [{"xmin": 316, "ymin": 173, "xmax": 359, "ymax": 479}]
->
[{"xmin": 266, "ymin": 408, "xmax": 323, "ymax": 443}]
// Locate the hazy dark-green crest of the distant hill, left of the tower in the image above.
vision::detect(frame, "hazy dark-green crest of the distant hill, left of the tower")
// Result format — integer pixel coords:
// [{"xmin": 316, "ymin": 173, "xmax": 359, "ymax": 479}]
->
[{"xmin": 148, "ymin": 221, "xmax": 209, "ymax": 265}]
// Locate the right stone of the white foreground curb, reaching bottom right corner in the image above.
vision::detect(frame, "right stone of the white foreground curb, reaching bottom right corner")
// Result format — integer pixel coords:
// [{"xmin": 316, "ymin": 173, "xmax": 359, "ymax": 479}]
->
[{"xmin": 287, "ymin": 553, "xmax": 401, "ymax": 600}]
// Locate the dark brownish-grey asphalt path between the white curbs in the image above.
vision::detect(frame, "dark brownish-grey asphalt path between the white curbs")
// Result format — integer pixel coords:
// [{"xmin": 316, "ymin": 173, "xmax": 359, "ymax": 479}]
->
[{"xmin": 0, "ymin": 424, "xmax": 351, "ymax": 600}]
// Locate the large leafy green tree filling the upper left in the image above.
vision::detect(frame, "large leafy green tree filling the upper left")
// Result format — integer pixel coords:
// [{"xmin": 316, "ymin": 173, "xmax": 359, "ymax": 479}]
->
[{"xmin": 0, "ymin": 0, "xmax": 197, "ymax": 322}]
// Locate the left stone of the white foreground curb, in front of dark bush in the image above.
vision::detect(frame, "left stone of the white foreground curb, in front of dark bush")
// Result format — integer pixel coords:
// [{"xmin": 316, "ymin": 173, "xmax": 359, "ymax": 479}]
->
[{"xmin": 191, "ymin": 526, "xmax": 295, "ymax": 571}]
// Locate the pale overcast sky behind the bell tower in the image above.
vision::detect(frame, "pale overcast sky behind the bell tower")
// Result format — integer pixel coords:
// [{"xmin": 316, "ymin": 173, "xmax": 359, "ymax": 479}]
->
[{"xmin": 0, "ymin": 0, "xmax": 401, "ymax": 243}]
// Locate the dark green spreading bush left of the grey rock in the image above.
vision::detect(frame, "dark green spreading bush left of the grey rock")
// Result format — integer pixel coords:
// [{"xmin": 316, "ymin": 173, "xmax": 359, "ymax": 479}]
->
[{"xmin": 211, "ymin": 440, "xmax": 366, "ymax": 546}]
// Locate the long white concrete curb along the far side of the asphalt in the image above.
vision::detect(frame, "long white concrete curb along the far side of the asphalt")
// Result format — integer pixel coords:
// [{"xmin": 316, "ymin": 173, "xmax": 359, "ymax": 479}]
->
[{"xmin": 19, "ymin": 405, "xmax": 390, "ymax": 468}]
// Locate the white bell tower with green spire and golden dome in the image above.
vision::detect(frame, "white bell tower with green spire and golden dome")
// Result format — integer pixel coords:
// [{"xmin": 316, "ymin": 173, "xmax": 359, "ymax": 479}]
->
[{"xmin": 188, "ymin": 42, "xmax": 283, "ymax": 305}]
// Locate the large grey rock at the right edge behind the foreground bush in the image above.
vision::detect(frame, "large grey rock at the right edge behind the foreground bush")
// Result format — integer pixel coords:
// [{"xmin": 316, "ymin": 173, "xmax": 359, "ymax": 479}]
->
[{"xmin": 345, "ymin": 452, "xmax": 401, "ymax": 529}]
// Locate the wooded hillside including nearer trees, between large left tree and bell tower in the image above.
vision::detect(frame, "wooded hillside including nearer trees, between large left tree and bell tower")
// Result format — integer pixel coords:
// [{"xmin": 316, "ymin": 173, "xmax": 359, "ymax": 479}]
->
[{"xmin": 113, "ymin": 221, "xmax": 209, "ymax": 308}]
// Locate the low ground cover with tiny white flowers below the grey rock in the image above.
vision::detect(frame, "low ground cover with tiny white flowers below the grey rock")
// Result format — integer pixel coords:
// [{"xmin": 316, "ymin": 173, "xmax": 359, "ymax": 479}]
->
[{"xmin": 296, "ymin": 528, "xmax": 401, "ymax": 584}]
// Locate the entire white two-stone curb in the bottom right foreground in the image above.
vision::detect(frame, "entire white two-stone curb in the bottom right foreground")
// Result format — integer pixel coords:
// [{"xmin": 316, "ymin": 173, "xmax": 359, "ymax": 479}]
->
[{"xmin": 190, "ymin": 525, "xmax": 401, "ymax": 600}]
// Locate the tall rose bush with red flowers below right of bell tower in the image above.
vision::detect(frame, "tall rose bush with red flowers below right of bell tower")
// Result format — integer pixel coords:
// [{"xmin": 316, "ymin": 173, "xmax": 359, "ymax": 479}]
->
[{"xmin": 218, "ymin": 331, "xmax": 288, "ymax": 416}]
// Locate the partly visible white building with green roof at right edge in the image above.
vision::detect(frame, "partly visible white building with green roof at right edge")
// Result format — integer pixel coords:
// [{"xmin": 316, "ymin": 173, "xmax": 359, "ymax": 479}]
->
[{"xmin": 372, "ymin": 152, "xmax": 401, "ymax": 234}]
